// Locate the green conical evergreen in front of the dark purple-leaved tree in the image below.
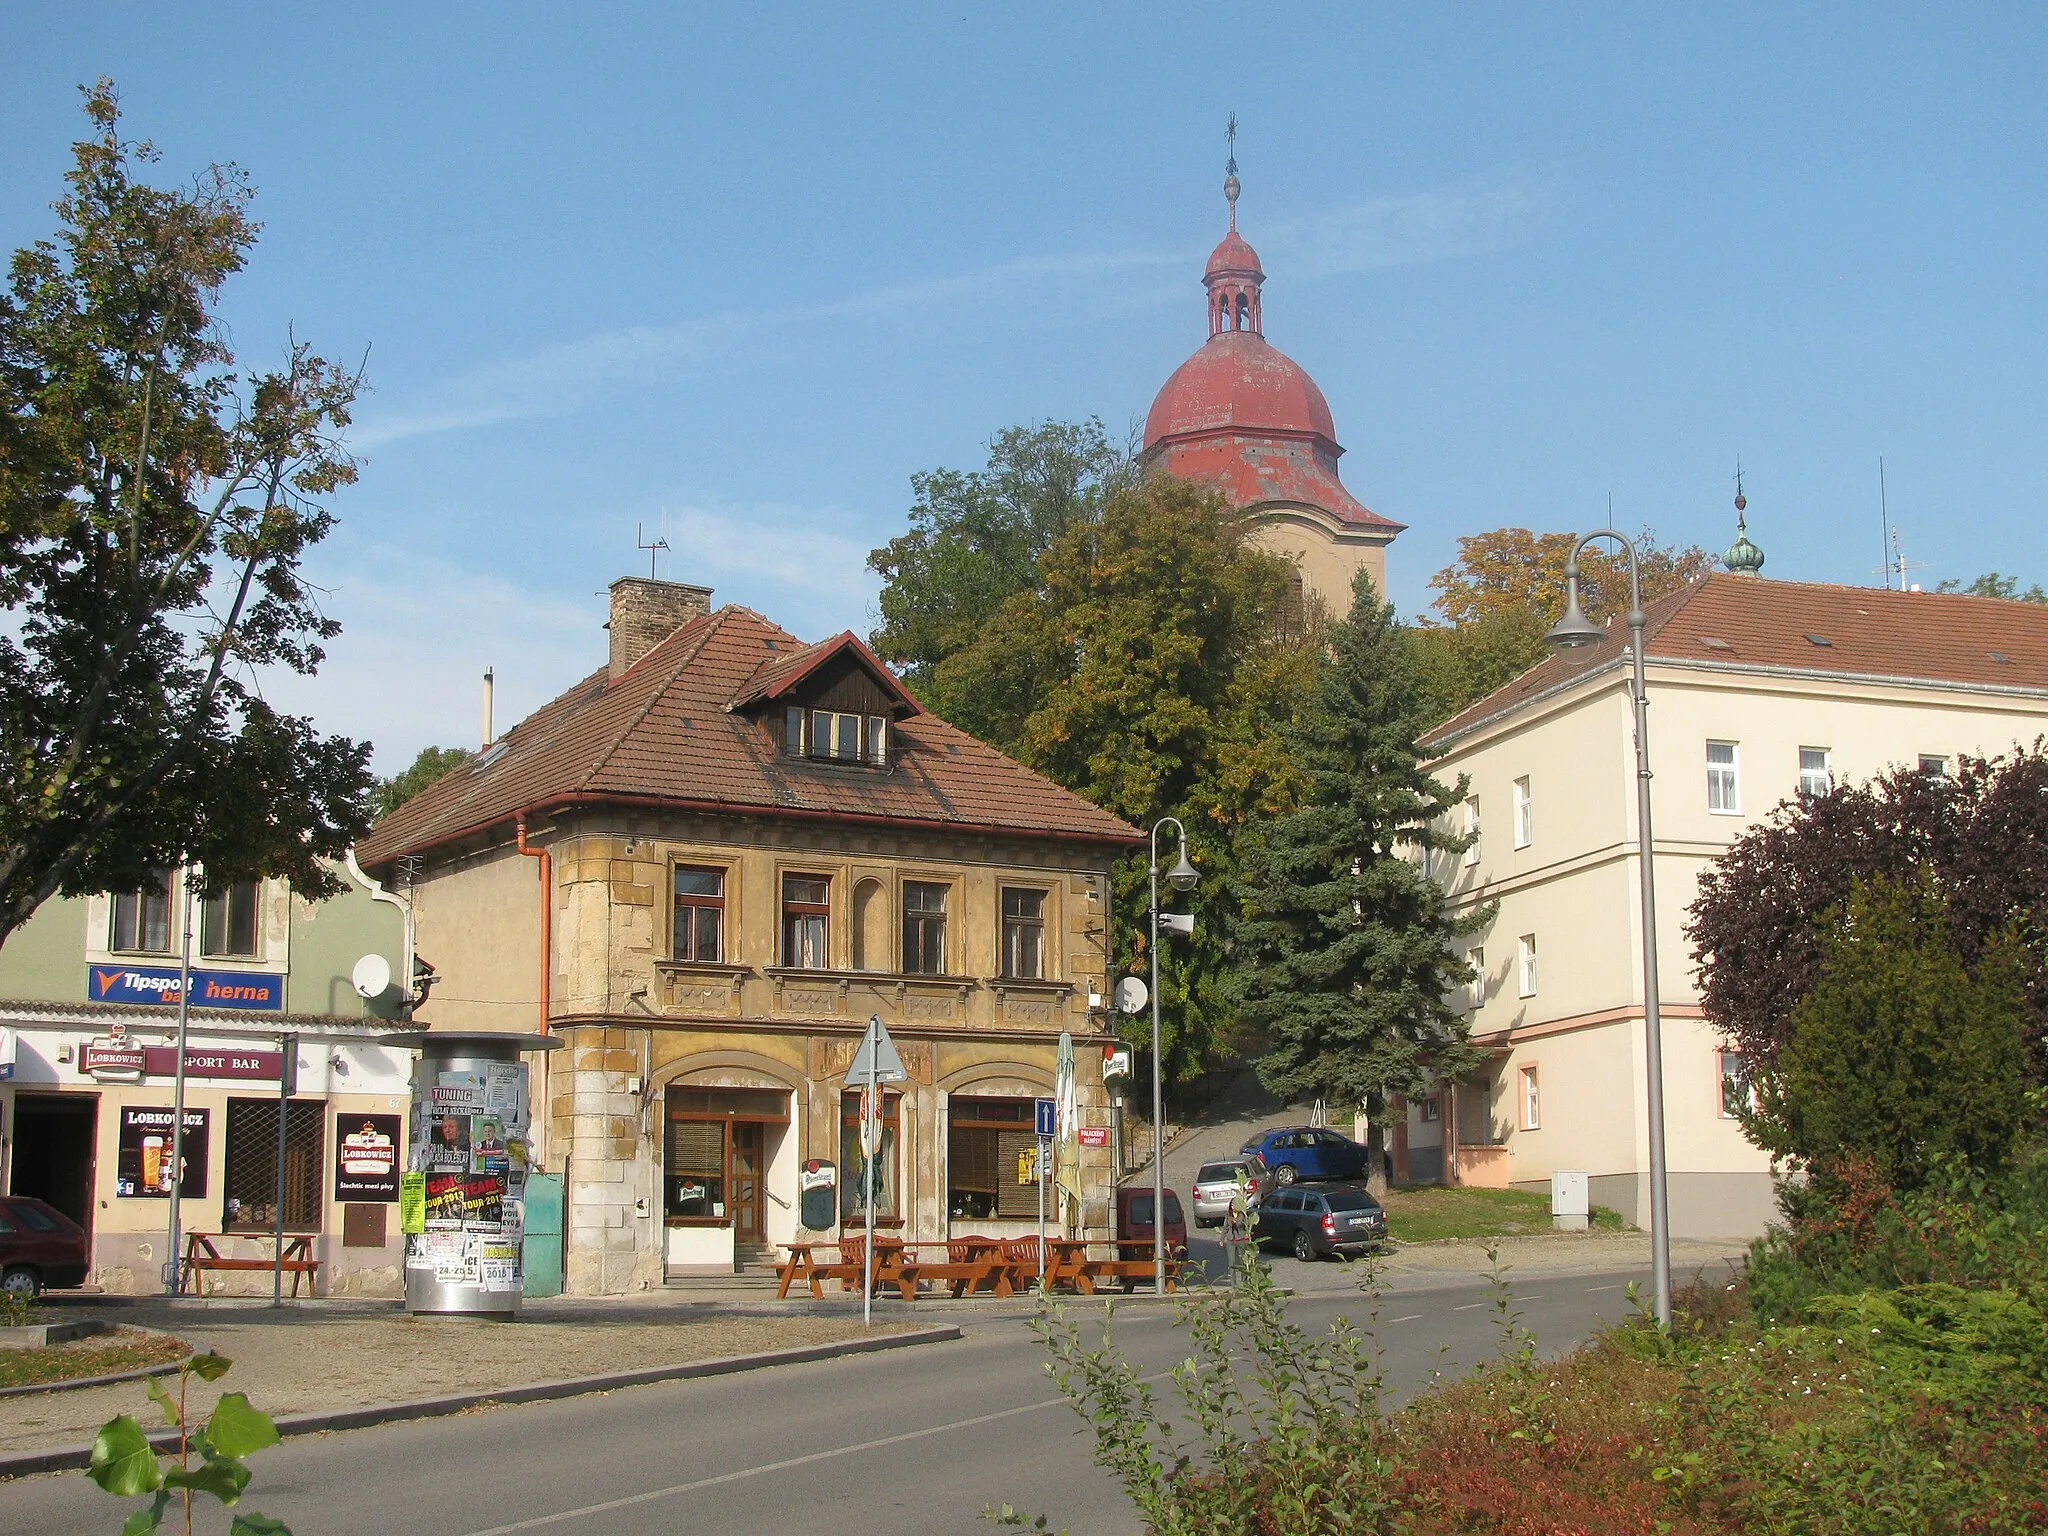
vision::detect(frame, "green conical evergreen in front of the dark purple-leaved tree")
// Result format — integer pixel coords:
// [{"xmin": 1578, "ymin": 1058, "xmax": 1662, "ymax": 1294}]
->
[{"xmin": 1747, "ymin": 872, "xmax": 2028, "ymax": 1188}]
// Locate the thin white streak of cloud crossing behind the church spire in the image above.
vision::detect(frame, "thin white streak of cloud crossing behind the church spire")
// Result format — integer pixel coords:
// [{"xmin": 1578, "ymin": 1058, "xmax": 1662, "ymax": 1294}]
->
[{"xmin": 352, "ymin": 184, "xmax": 1546, "ymax": 449}]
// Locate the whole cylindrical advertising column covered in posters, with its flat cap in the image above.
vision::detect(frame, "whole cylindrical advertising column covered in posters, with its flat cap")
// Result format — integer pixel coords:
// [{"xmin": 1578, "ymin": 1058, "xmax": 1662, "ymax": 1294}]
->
[{"xmin": 391, "ymin": 1030, "xmax": 561, "ymax": 1317}]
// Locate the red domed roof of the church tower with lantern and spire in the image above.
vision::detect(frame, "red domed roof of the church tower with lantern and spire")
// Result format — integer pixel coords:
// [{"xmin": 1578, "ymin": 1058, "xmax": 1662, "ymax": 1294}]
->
[{"xmin": 1145, "ymin": 160, "xmax": 1403, "ymax": 532}]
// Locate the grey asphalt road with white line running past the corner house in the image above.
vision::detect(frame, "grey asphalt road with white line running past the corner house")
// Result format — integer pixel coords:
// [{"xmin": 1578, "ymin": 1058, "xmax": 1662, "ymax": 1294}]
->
[{"xmin": 0, "ymin": 1260, "xmax": 1638, "ymax": 1536}]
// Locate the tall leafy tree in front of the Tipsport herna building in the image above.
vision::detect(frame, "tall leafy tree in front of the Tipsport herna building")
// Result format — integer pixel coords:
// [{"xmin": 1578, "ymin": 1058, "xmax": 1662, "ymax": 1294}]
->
[{"xmin": 0, "ymin": 80, "xmax": 369, "ymax": 938}]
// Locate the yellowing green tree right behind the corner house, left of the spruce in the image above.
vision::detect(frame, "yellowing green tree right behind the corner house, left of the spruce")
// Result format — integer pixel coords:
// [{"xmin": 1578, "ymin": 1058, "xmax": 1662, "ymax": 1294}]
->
[{"xmin": 938, "ymin": 475, "xmax": 1317, "ymax": 1081}]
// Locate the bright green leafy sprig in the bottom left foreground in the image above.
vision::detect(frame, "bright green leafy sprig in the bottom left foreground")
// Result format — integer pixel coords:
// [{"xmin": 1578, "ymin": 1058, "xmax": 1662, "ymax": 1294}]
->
[{"xmin": 86, "ymin": 1354, "xmax": 291, "ymax": 1536}]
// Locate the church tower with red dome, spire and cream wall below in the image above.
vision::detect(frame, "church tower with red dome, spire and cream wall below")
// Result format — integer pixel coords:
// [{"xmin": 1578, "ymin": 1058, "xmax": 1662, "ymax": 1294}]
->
[{"xmin": 1143, "ymin": 131, "xmax": 1405, "ymax": 618}]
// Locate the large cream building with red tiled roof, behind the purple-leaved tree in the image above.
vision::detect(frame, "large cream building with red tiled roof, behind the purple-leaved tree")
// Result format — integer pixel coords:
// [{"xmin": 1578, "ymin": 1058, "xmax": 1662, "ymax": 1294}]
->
[{"xmin": 1405, "ymin": 575, "xmax": 2048, "ymax": 1237}]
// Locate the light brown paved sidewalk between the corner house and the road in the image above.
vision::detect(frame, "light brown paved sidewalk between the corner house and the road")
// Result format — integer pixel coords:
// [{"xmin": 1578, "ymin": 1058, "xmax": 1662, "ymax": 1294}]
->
[{"xmin": 0, "ymin": 1303, "xmax": 905, "ymax": 1452}]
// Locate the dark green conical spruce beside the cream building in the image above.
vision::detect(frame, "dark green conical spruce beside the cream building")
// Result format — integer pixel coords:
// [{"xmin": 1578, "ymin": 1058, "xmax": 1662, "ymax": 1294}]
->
[{"xmin": 1237, "ymin": 571, "xmax": 1491, "ymax": 1118}]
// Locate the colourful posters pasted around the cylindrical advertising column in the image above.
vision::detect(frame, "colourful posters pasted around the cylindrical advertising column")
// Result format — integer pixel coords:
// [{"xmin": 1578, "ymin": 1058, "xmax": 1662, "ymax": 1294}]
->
[{"xmin": 399, "ymin": 1061, "xmax": 530, "ymax": 1294}]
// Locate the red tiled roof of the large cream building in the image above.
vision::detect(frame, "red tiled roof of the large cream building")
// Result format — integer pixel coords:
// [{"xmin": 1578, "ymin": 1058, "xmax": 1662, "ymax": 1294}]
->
[{"xmin": 1425, "ymin": 571, "xmax": 2048, "ymax": 743}]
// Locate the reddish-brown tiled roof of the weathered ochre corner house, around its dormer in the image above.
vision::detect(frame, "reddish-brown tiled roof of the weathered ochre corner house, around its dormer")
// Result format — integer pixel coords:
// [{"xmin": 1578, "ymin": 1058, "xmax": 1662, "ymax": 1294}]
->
[{"xmin": 356, "ymin": 606, "xmax": 1143, "ymax": 866}]
